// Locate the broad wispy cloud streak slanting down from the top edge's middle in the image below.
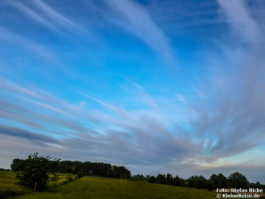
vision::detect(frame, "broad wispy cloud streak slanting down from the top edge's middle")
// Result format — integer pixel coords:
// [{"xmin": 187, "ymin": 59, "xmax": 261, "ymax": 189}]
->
[{"xmin": 105, "ymin": 0, "xmax": 176, "ymax": 63}]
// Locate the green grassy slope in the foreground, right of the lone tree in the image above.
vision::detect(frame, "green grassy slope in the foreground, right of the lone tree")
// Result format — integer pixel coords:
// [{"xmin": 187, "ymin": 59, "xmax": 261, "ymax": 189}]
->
[{"xmin": 11, "ymin": 177, "xmax": 216, "ymax": 199}]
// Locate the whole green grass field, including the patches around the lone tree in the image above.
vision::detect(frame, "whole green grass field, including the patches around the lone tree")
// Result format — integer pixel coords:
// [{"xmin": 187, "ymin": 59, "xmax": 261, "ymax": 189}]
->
[{"xmin": 0, "ymin": 171, "xmax": 260, "ymax": 199}]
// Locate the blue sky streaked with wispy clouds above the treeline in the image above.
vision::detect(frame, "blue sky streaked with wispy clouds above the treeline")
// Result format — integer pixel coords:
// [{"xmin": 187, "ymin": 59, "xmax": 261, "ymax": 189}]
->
[{"xmin": 0, "ymin": 0, "xmax": 265, "ymax": 183}]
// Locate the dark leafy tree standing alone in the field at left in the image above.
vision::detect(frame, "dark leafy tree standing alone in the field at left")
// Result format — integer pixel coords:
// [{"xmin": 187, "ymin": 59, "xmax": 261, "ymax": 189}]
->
[{"xmin": 17, "ymin": 153, "xmax": 56, "ymax": 192}]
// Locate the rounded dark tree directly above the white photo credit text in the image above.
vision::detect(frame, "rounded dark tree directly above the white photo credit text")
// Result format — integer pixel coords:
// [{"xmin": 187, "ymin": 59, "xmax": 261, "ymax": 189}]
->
[{"xmin": 228, "ymin": 172, "xmax": 249, "ymax": 188}]
